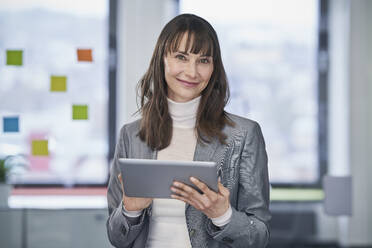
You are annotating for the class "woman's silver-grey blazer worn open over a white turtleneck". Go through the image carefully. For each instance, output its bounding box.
[106,114,271,248]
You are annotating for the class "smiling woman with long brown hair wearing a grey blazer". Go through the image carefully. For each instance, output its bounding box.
[107,14,270,248]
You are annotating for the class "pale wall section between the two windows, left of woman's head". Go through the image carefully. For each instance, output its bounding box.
[117,0,176,133]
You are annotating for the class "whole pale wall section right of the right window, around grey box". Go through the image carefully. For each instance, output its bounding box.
[329,0,372,246]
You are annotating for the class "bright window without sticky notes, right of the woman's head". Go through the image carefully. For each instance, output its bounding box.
[180,0,320,185]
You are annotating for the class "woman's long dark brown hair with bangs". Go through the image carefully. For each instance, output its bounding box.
[138,14,233,150]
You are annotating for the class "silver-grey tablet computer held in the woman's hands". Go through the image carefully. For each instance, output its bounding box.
[119,158,218,198]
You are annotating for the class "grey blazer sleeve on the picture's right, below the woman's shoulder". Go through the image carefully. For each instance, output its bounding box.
[207,123,271,248]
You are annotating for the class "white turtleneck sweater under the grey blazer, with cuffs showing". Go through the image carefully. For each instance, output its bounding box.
[124,96,232,248]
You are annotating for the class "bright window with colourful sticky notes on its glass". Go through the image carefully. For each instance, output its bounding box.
[0,0,109,185]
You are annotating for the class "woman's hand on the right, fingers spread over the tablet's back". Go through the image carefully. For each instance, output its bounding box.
[171,177,230,218]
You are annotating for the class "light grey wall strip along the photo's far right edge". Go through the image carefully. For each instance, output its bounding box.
[349,0,372,245]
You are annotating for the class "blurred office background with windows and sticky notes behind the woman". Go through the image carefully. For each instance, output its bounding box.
[0,0,372,248]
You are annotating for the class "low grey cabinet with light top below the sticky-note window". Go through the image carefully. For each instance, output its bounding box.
[0,188,112,248]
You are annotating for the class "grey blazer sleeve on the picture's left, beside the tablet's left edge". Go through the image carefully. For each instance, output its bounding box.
[106,126,148,248]
